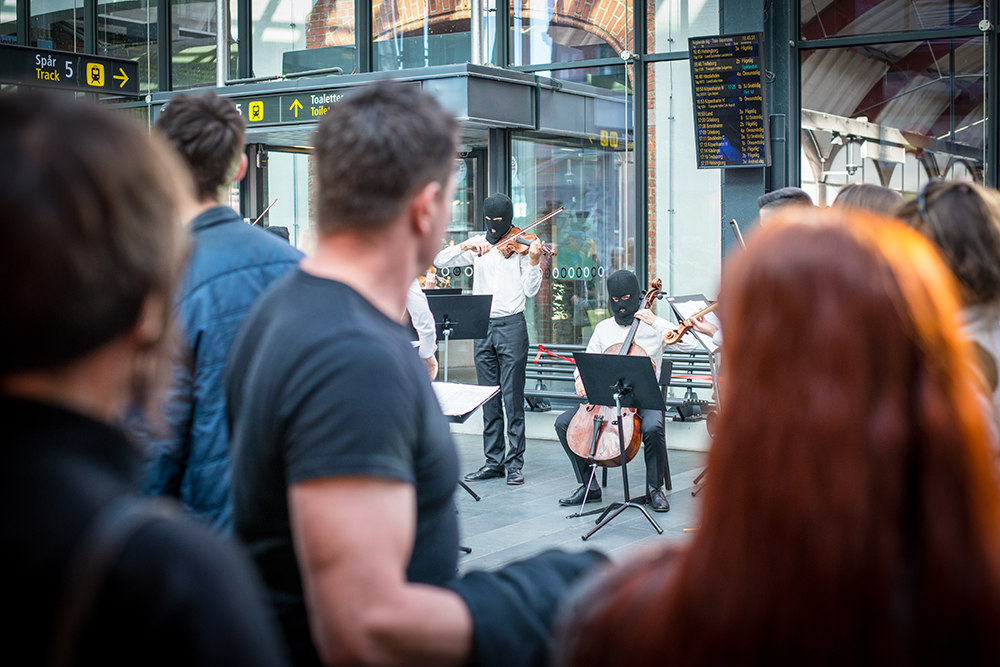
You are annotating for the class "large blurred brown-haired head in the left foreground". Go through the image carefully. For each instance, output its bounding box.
[0,93,190,375]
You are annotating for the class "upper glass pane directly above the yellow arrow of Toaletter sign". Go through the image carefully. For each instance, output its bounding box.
[252,0,354,76]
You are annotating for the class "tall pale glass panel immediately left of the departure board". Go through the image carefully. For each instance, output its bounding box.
[646,60,720,300]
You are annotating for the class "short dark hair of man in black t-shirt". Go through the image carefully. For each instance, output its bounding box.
[315,81,458,235]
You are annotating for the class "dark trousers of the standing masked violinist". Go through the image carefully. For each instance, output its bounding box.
[473,313,528,470]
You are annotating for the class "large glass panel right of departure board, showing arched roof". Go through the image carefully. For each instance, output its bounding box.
[801,37,988,200]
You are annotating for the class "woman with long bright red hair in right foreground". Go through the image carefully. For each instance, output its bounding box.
[557,209,1000,667]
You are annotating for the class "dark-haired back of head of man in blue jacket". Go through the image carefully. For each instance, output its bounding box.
[156,91,246,201]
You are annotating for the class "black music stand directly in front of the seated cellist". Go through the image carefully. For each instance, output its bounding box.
[573,352,666,540]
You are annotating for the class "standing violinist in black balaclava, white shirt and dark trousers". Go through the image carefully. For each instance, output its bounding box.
[434,193,542,485]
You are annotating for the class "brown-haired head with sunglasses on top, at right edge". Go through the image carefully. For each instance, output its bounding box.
[897,181,1000,304]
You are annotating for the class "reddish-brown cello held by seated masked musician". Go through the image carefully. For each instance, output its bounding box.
[566,278,663,468]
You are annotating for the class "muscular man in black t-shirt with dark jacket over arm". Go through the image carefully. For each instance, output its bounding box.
[226,83,600,666]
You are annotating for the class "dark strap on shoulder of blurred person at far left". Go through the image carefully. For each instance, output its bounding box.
[48,495,178,667]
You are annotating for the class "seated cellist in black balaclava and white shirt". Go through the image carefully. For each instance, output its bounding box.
[556,271,697,512]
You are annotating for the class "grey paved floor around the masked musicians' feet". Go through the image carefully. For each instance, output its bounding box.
[454,433,705,573]
